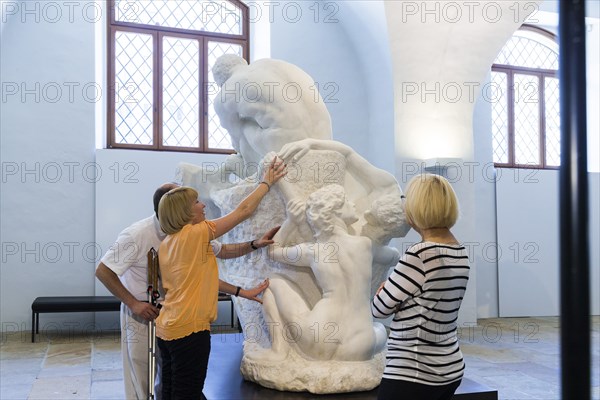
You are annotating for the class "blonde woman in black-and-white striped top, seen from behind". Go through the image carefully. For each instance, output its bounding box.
[371,174,469,400]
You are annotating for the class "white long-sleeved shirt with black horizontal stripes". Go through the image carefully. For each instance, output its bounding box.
[371,242,469,385]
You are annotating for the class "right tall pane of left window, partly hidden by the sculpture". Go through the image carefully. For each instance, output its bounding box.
[207,41,243,149]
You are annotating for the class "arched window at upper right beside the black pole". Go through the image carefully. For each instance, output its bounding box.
[492,26,560,168]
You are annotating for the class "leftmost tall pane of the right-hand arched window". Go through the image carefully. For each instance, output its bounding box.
[489,72,508,164]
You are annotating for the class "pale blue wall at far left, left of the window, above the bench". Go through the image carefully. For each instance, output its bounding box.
[0,2,97,332]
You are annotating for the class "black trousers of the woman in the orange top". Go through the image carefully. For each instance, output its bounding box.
[157,331,210,400]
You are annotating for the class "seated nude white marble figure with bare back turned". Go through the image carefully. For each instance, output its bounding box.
[258,184,387,361]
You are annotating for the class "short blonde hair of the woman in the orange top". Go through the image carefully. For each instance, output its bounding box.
[158,186,198,235]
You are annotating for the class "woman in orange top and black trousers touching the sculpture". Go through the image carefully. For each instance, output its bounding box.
[156,158,285,400]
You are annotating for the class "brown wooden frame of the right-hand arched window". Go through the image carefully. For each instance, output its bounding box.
[492,25,560,169]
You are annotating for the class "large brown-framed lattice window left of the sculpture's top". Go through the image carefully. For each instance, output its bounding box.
[107,0,249,153]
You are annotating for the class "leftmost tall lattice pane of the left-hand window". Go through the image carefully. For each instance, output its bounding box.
[115,31,153,145]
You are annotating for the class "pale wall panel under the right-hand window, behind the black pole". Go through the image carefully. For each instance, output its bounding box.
[496,169,600,317]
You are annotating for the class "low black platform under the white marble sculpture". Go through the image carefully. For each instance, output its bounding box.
[204,334,498,400]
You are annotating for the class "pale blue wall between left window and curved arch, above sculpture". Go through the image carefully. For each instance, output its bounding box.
[264,1,369,157]
